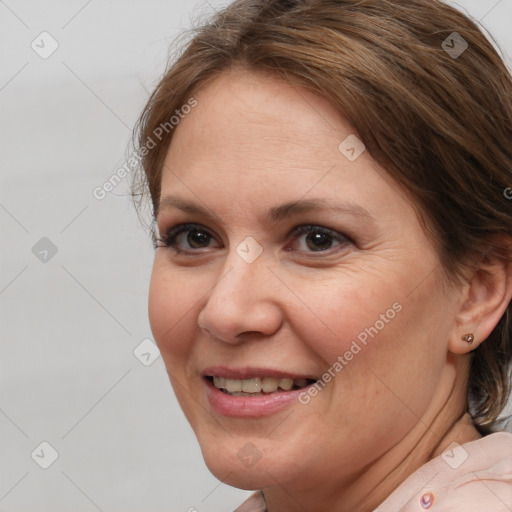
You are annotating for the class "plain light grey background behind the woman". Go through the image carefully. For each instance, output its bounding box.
[0,0,512,512]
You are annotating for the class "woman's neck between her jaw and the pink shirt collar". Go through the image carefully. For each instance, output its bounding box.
[263,360,482,512]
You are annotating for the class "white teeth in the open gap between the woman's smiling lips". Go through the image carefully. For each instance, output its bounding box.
[205,375,316,397]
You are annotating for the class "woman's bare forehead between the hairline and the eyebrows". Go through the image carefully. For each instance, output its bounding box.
[162,71,416,225]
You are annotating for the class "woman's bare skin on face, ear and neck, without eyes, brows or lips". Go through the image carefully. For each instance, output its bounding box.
[149,70,512,512]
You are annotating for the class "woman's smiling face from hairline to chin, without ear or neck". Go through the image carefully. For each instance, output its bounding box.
[149,71,459,489]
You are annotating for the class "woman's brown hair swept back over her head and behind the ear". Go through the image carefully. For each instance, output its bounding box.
[132,0,512,435]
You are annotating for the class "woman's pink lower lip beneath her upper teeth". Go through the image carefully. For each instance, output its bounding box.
[204,379,307,418]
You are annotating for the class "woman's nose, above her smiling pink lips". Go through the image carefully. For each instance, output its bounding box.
[197,254,282,344]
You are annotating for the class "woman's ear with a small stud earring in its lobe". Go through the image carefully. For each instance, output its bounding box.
[448,246,512,354]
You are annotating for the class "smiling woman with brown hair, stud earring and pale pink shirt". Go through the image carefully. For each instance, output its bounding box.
[135,0,512,512]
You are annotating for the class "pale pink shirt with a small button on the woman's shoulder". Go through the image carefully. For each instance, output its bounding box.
[235,432,512,512]
